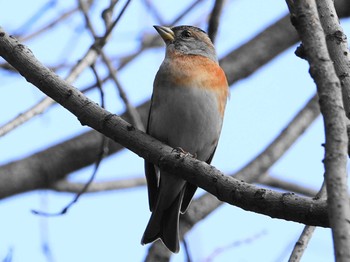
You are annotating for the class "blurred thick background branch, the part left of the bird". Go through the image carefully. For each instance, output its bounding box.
[0,102,149,199]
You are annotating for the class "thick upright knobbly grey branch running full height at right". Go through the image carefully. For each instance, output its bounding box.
[291,0,350,261]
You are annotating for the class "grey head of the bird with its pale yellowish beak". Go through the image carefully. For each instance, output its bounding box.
[154,25,218,62]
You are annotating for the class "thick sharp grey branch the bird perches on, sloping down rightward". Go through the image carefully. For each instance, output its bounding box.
[0,26,328,226]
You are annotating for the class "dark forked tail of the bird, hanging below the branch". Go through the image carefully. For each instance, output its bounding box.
[141,185,185,253]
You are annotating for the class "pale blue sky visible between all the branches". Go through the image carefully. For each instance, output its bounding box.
[0,0,350,262]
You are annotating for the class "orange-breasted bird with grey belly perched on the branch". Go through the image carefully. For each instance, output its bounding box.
[141,25,229,253]
